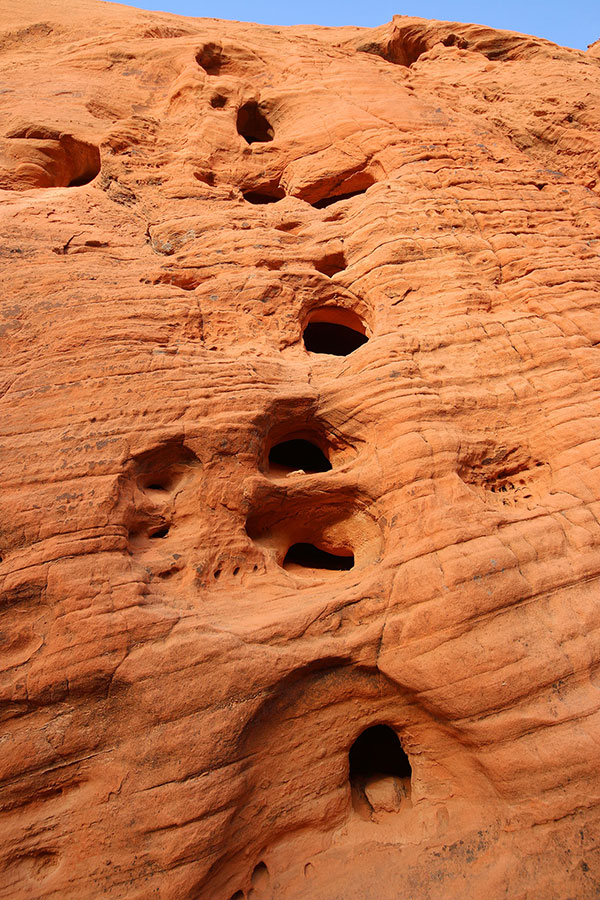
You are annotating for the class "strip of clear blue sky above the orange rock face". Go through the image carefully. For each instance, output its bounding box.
[110,0,600,50]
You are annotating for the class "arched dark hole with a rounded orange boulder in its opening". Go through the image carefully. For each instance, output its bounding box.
[349,725,412,818]
